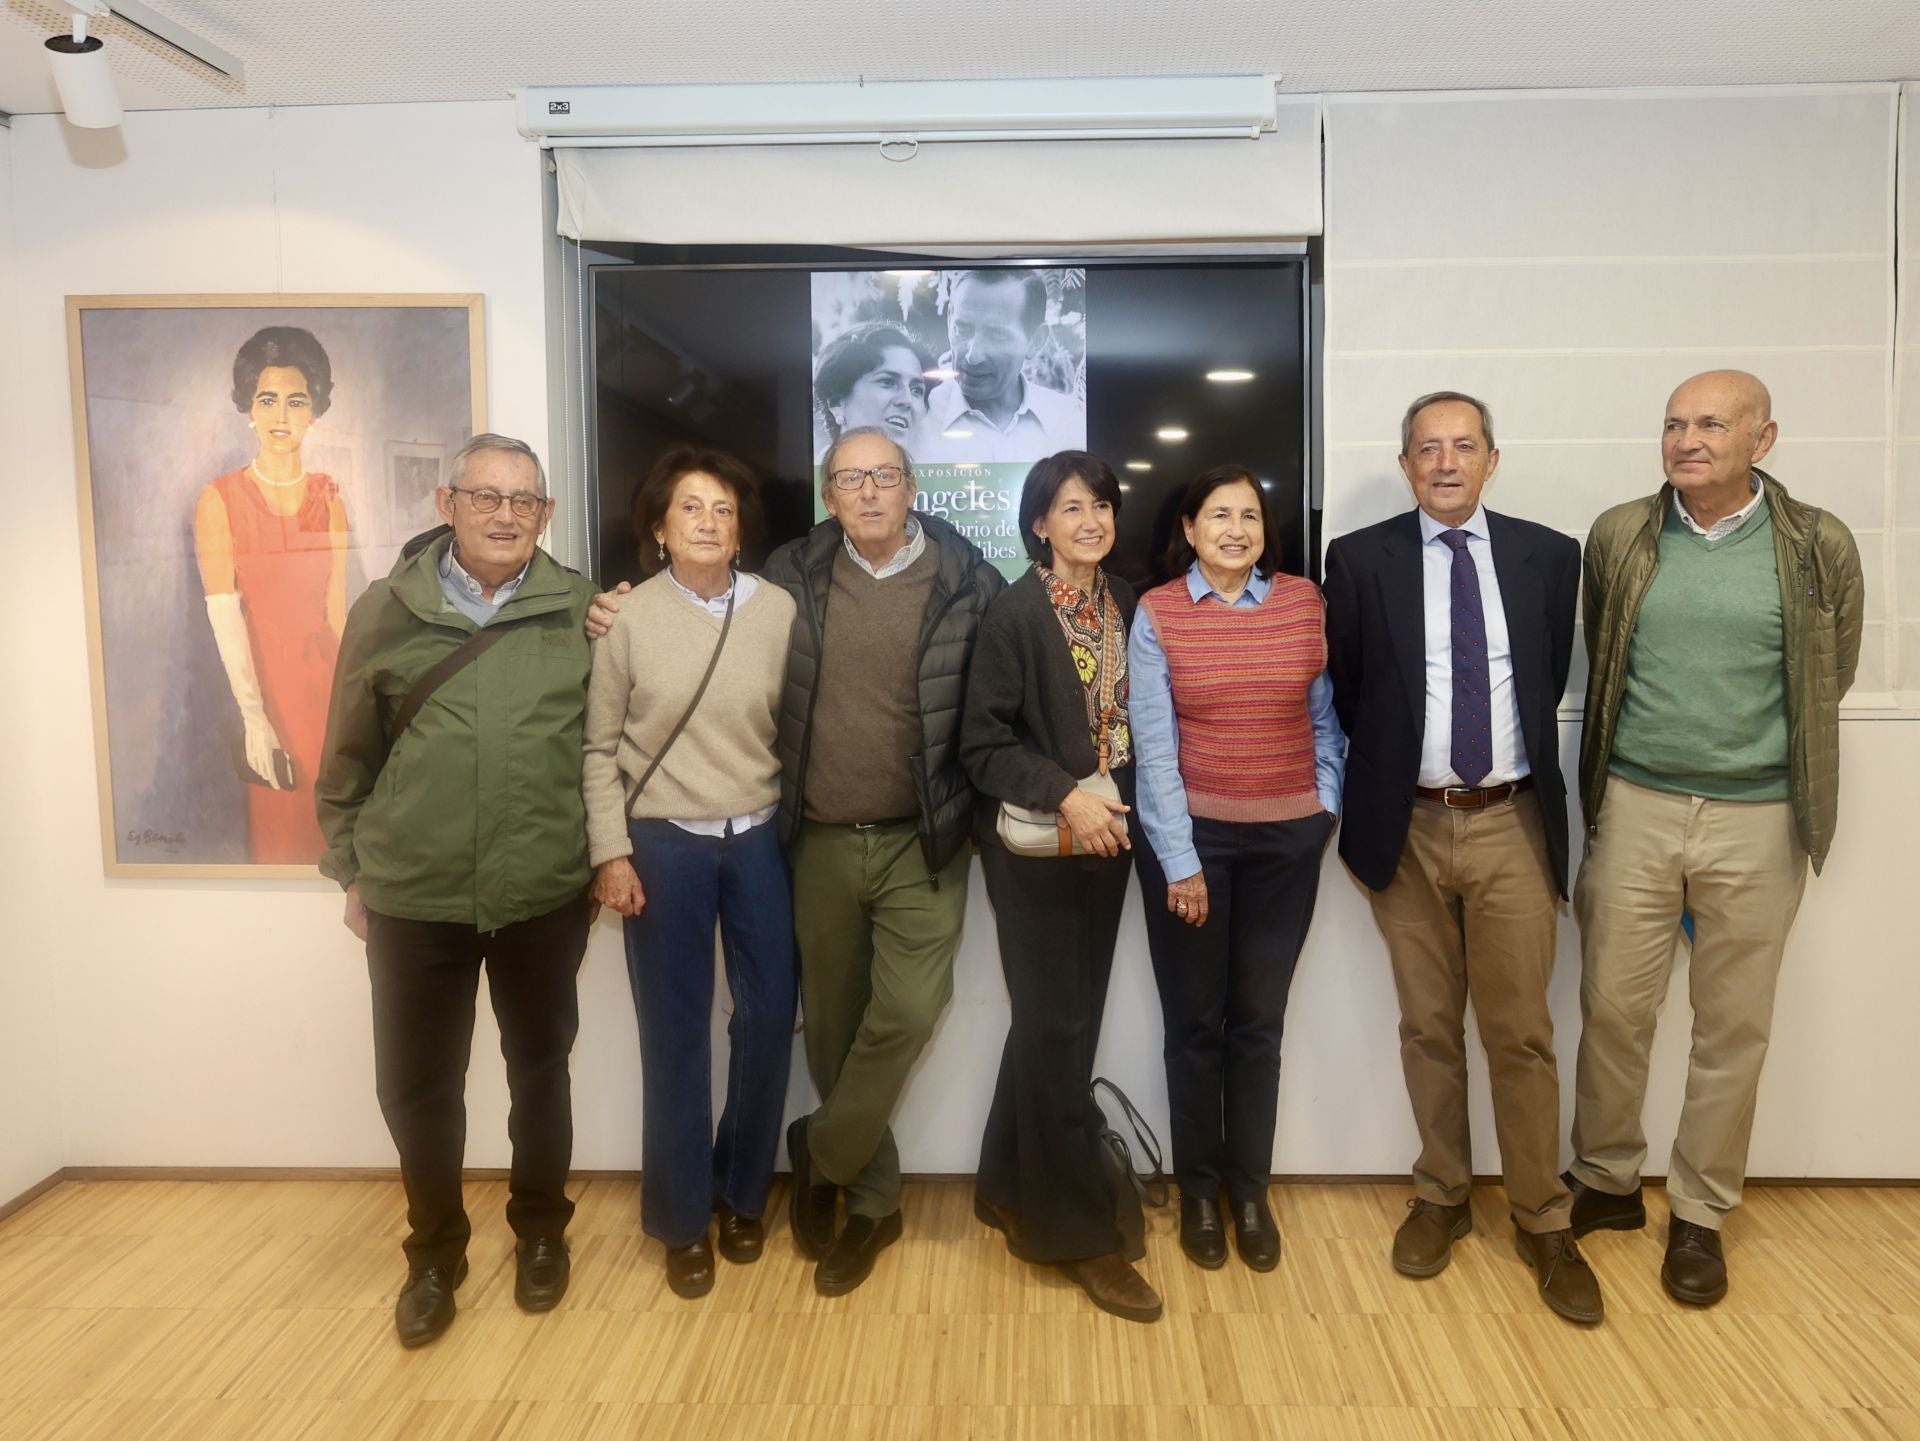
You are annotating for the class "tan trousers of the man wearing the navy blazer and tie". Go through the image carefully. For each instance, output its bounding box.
[1371,792,1571,1232]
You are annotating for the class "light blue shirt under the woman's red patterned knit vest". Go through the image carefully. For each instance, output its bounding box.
[1127,560,1346,881]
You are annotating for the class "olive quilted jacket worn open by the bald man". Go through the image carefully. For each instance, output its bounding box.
[1580,468,1866,875]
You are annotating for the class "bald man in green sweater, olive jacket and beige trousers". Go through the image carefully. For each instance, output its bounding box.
[1567,370,1862,1307]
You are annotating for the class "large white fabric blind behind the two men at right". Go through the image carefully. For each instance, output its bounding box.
[1323,84,1920,708]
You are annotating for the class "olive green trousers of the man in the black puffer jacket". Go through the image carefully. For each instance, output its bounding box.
[787,821,973,1220]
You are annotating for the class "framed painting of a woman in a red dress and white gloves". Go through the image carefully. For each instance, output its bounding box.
[67,295,486,879]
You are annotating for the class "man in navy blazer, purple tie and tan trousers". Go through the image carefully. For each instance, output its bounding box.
[1327,391,1603,1324]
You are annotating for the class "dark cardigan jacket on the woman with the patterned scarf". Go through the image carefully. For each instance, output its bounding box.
[960,570,1133,844]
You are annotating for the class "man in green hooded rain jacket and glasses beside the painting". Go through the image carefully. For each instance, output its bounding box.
[315,436,593,1347]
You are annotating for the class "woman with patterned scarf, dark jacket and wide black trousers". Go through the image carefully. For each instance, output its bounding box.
[960,451,1162,1320]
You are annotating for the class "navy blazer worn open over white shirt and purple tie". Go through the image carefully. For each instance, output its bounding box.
[1325,510,1580,896]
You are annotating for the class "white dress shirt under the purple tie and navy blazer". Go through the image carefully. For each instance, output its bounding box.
[1419,507,1530,787]
